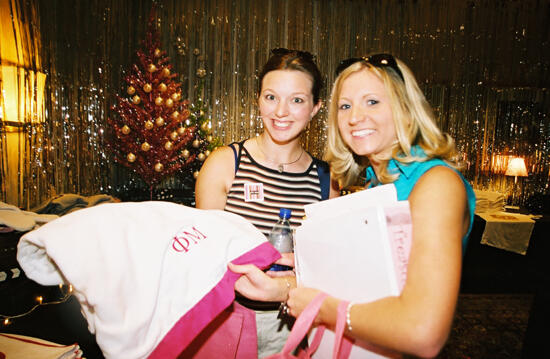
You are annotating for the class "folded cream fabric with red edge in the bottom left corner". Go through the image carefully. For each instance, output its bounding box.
[0,333,82,359]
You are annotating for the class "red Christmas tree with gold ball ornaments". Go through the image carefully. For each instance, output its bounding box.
[107,9,216,199]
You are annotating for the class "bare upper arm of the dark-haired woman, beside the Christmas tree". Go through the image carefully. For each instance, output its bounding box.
[195,146,235,210]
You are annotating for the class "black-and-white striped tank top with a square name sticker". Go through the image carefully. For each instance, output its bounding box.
[224,141,321,236]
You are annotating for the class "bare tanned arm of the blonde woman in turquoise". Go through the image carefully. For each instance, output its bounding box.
[288,166,469,357]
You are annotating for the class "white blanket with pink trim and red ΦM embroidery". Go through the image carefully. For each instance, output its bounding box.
[17,202,279,359]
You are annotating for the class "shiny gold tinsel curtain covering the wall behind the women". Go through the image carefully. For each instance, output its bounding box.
[0,0,550,208]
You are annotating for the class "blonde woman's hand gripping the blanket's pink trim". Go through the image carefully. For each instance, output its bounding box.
[227,263,286,302]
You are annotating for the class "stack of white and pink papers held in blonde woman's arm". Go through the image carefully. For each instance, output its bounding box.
[294,184,412,358]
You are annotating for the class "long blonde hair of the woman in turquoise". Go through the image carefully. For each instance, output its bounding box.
[324,59,459,188]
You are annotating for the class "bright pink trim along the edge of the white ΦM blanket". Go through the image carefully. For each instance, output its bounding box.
[148,242,281,359]
